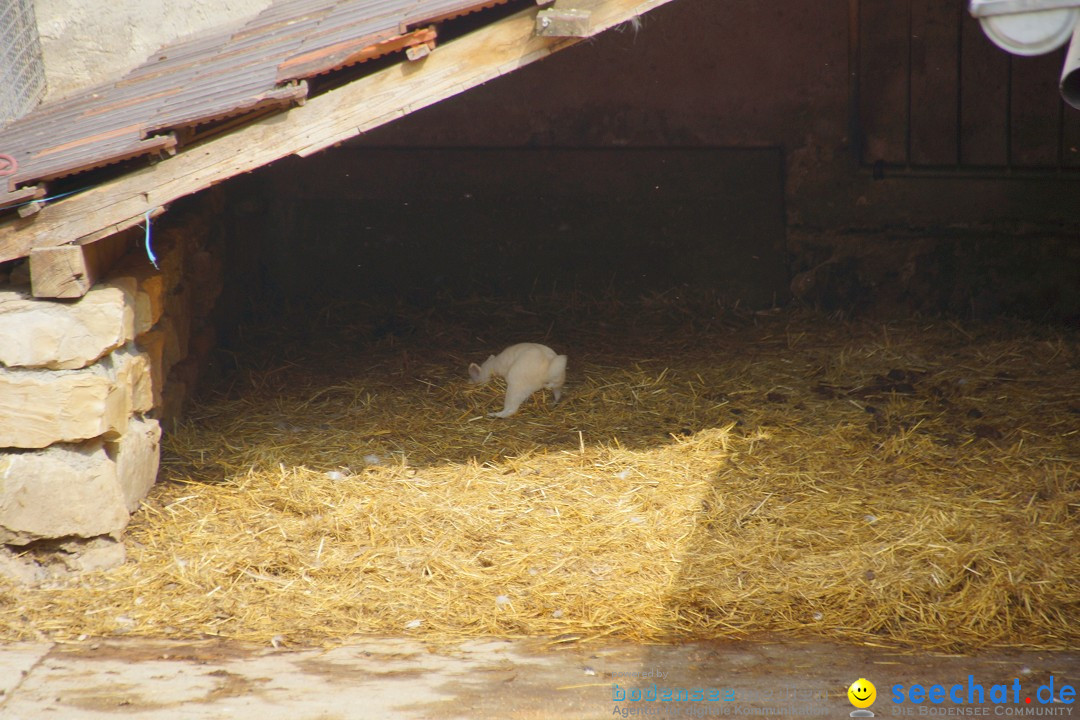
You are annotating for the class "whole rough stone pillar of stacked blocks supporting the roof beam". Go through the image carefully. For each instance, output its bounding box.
[0,203,222,575]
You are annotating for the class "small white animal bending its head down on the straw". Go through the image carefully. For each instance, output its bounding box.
[469,342,566,418]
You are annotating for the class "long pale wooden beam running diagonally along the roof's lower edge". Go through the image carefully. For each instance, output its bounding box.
[0,0,671,261]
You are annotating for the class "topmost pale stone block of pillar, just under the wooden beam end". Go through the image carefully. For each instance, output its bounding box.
[0,277,136,370]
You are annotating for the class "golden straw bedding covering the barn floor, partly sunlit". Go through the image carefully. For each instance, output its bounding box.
[0,297,1080,651]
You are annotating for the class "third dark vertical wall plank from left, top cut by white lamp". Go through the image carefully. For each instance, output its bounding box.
[960,8,1009,166]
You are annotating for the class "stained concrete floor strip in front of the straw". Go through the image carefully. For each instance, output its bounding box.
[0,638,1080,720]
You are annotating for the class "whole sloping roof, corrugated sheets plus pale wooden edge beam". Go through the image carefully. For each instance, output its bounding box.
[0,0,671,268]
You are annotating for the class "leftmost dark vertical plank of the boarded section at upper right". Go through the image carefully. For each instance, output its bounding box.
[859,0,909,163]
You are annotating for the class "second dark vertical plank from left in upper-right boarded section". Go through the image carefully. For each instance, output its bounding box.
[910,0,961,165]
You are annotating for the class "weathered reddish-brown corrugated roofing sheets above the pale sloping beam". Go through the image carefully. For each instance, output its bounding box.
[0,0,510,208]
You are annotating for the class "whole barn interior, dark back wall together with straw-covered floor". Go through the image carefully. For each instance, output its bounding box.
[2,0,1080,652]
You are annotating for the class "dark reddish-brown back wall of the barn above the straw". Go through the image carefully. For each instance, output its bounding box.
[210,0,1080,323]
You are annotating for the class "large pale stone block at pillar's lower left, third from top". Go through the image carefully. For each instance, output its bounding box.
[0,440,127,545]
